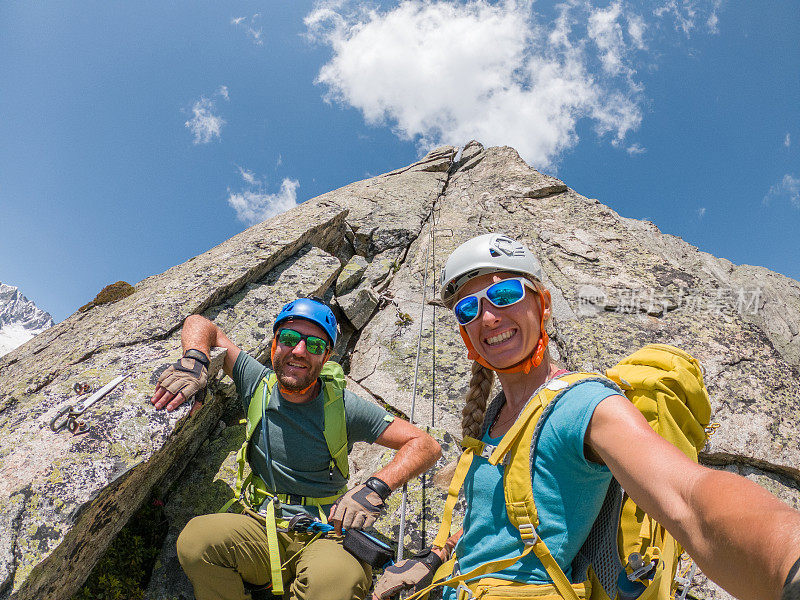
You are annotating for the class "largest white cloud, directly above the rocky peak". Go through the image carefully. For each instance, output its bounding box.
[305,0,645,167]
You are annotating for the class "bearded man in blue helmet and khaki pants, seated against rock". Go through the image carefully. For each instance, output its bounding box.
[151,298,441,600]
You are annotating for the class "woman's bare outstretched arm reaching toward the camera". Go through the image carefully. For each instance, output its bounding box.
[585,396,800,600]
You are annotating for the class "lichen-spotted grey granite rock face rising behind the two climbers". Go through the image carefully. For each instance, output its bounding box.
[0,142,800,600]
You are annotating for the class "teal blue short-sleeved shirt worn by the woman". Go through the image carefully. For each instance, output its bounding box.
[445,381,619,598]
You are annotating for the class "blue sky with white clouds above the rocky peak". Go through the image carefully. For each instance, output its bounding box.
[0,0,800,321]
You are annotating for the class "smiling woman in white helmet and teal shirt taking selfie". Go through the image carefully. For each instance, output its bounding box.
[373,234,800,600]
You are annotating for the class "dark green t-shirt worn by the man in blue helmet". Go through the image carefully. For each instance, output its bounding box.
[233,352,393,498]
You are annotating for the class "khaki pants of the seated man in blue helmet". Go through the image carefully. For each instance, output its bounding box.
[177,513,372,600]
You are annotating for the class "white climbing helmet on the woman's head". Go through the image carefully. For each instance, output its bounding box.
[441,233,542,308]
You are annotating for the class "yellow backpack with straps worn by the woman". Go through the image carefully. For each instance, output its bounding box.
[409,344,711,600]
